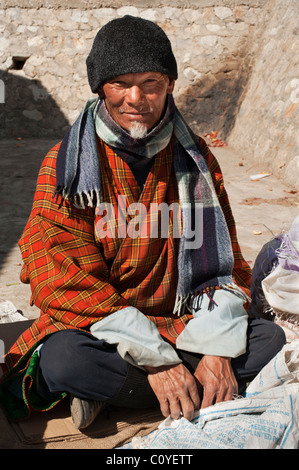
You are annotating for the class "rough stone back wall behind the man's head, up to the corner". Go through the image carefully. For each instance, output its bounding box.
[0,0,265,138]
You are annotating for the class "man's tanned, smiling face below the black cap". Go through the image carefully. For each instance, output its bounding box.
[103,72,175,131]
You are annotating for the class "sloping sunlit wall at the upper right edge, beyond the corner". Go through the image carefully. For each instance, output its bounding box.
[229,0,299,189]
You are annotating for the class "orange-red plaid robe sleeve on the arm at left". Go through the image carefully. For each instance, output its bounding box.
[19,146,128,328]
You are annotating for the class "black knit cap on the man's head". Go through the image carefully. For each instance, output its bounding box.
[86,15,178,93]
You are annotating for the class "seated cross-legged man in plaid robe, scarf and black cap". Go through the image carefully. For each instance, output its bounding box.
[0,16,285,429]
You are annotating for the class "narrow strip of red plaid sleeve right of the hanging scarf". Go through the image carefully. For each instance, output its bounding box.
[199,138,251,296]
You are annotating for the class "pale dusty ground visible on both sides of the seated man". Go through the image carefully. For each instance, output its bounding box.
[0,139,299,448]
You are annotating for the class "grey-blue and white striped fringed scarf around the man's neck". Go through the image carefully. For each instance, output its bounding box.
[55,96,248,315]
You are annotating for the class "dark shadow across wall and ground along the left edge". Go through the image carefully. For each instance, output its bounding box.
[0,70,69,268]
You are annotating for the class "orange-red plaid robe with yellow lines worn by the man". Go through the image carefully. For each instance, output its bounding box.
[1,139,251,375]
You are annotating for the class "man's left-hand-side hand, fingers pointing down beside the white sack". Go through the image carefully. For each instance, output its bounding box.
[146,364,200,421]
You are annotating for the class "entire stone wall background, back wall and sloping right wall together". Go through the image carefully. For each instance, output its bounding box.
[0,0,299,188]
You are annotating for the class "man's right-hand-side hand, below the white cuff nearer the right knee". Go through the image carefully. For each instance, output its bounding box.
[194,356,238,408]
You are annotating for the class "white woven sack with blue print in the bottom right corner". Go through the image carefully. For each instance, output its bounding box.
[130,340,299,449]
